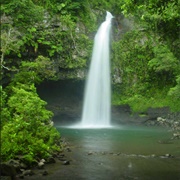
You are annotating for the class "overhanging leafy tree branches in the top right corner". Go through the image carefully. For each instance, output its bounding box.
[121,0,180,53]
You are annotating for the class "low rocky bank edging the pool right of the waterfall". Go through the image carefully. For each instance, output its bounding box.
[112,105,180,139]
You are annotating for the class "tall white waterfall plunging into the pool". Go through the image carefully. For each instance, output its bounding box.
[82,12,113,128]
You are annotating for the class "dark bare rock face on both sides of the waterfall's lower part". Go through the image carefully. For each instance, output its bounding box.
[37,80,179,126]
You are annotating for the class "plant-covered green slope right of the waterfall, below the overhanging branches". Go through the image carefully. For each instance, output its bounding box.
[112,27,180,112]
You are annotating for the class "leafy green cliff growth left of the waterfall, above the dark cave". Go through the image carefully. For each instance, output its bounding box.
[1,0,95,81]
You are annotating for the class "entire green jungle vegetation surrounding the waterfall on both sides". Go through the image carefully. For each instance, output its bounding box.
[0,0,180,164]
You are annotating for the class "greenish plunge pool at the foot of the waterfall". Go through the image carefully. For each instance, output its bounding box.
[58,126,180,180]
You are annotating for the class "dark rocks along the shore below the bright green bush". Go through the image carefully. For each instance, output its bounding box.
[0,141,71,180]
